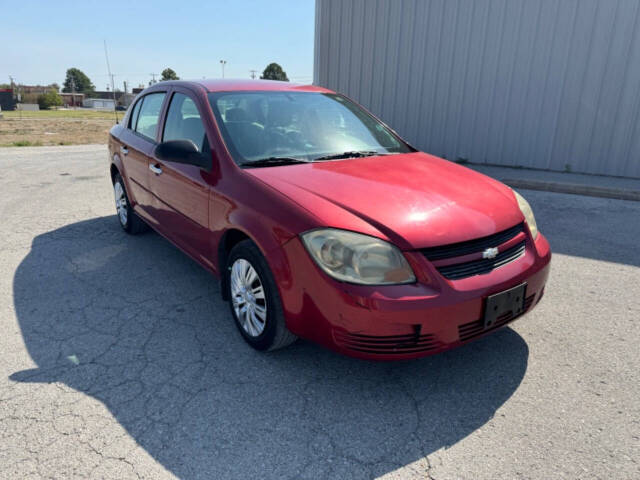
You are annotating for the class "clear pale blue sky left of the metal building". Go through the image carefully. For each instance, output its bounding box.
[0,0,315,90]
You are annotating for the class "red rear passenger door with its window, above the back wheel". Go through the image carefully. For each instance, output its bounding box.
[120,92,167,220]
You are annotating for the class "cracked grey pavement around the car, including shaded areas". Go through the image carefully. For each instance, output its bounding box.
[0,146,640,480]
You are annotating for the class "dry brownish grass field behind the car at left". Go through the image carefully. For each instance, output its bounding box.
[0,110,125,147]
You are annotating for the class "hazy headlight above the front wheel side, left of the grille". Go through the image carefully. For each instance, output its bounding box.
[301,228,416,285]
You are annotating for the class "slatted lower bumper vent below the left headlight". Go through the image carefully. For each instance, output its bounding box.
[334,330,441,355]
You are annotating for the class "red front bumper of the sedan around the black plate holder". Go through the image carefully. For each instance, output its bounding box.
[274,234,551,360]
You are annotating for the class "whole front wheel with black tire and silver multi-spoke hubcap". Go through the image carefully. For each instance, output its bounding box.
[226,240,297,350]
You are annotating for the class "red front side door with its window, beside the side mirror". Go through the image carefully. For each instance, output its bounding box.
[149,87,212,266]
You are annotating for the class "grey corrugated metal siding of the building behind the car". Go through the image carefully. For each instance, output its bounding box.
[314,0,640,177]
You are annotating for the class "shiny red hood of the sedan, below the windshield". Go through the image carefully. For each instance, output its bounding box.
[245,152,523,249]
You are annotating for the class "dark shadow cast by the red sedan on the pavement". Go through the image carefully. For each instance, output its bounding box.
[10,217,528,479]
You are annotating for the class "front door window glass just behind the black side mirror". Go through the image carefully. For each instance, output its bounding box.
[162,93,205,152]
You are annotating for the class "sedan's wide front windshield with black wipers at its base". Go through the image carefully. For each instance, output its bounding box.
[209,91,413,166]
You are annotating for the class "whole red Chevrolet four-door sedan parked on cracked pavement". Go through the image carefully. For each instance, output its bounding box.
[109,80,551,360]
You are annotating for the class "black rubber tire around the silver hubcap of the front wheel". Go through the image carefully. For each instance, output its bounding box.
[225,240,298,351]
